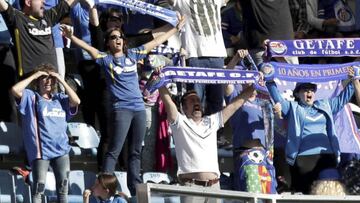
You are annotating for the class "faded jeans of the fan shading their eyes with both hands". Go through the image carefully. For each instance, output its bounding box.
[32,154,70,203]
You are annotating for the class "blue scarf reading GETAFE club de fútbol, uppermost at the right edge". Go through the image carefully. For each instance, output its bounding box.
[266,38,360,57]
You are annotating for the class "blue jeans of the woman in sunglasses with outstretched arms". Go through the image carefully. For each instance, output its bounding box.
[103,109,146,196]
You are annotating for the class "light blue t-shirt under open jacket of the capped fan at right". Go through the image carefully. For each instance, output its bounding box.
[299,106,333,155]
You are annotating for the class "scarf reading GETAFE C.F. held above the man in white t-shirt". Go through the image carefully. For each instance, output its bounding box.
[146,66,260,92]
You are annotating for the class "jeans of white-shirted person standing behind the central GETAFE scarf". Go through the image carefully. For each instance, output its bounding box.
[187,57,224,115]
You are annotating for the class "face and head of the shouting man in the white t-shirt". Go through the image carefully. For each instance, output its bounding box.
[183,94,202,119]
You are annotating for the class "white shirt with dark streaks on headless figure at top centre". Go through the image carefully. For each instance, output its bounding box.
[173,0,226,58]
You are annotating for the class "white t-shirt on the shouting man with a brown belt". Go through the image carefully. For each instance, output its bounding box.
[170,112,223,177]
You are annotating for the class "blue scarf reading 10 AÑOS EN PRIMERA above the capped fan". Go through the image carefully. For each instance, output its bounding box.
[260,62,360,82]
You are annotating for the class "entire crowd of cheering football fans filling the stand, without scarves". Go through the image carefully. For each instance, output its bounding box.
[0,0,360,202]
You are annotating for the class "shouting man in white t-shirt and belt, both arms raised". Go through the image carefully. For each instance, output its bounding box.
[159,80,254,203]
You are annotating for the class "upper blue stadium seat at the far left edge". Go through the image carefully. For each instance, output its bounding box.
[0,121,24,155]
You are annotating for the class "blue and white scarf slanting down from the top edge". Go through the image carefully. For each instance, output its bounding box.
[95,0,178,27]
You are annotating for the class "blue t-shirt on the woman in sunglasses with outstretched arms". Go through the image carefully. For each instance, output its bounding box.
[96,46,147,111]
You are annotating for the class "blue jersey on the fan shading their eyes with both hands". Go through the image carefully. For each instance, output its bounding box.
[18,89,77,164]
